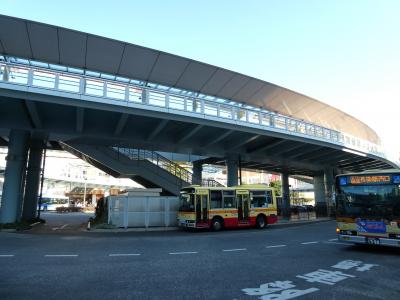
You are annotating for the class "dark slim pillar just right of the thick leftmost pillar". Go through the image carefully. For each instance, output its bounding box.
[22,139,44,220]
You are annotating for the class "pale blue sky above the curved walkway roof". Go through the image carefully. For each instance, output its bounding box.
[0,0,400,160]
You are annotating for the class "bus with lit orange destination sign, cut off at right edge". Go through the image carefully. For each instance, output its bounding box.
[335,169,400,247]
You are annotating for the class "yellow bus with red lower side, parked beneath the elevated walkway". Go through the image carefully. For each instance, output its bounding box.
[178,185,278,231]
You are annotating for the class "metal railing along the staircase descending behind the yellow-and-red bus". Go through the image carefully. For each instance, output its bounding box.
[113,147,223,186]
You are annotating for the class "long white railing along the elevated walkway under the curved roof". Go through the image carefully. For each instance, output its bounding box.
[0,57,386,158]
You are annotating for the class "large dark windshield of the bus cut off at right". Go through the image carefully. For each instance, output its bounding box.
[336,184,400,218]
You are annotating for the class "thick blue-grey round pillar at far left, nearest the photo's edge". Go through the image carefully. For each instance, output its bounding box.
[0,130,29,223]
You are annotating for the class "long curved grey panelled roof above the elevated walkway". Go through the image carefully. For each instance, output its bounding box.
[0,15,380,144]
